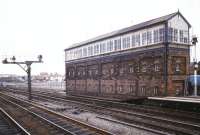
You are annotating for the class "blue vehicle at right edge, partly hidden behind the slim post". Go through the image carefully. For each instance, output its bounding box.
[185,75,200,96]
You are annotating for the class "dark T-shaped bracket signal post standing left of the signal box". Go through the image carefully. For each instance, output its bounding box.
[2,55,43,100]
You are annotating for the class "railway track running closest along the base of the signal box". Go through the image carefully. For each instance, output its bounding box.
[3,86,200,123]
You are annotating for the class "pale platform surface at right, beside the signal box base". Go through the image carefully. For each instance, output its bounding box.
[148,96,200,104]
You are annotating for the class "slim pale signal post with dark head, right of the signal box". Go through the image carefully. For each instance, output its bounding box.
[192,36,198,96]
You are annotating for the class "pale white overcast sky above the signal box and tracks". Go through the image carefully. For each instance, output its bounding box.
[0,0,200,75]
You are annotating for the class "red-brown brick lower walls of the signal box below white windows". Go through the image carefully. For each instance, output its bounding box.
[66,48,189,97]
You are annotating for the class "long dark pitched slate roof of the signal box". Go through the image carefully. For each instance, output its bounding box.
[65,11,191,51]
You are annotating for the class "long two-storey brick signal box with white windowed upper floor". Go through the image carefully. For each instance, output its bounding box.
[65,12,191,99]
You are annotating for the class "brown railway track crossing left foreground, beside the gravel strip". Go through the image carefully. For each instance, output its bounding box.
[0,91,112,135]
